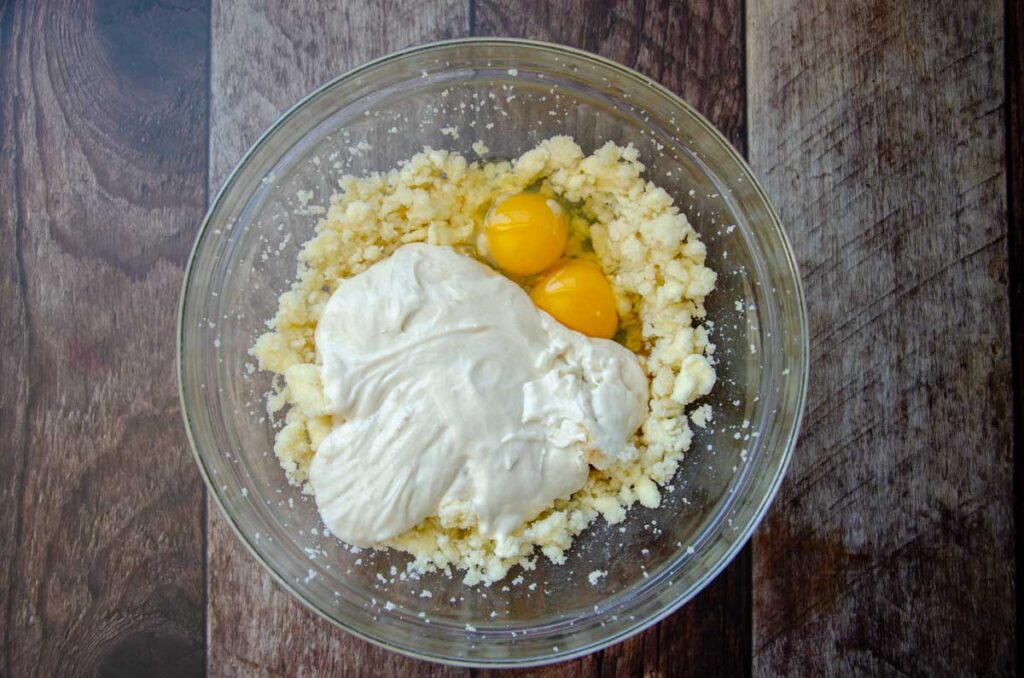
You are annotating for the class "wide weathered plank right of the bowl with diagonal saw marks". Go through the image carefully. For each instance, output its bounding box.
[746,0,1020,675]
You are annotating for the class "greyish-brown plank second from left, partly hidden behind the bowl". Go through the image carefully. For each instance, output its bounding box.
[208,0,469,676]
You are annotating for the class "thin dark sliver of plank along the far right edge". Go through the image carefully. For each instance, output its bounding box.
[1006,0,1024,673]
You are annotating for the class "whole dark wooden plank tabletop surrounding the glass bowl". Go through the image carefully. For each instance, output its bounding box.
[0,0,1024,676]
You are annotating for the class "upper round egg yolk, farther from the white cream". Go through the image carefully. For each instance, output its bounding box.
[484,193,569,276]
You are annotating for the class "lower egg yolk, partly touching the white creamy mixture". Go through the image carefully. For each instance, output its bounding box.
[529,259,618,339]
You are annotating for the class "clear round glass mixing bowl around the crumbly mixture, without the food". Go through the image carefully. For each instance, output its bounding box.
[177,39,808,667]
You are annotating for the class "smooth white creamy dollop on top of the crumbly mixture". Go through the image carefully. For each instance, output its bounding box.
[309,244,647,546]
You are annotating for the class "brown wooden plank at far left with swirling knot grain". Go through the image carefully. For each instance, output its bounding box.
[0,0,209,676]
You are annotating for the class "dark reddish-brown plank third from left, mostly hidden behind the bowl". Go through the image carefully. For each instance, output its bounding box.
[474,0,751,676]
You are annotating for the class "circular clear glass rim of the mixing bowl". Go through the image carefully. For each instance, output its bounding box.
[175,37,810,668]
